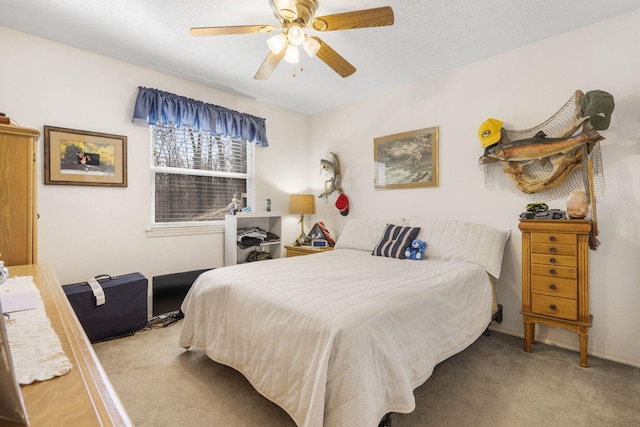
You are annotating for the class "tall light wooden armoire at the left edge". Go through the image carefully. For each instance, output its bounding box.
[0,124,40,266]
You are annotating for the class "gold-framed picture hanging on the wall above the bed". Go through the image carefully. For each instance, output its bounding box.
[373,126,439,190]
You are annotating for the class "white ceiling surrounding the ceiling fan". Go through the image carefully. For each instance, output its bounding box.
[0,0,640,114]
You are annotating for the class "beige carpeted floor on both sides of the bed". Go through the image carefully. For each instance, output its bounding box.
[94,322,640,427]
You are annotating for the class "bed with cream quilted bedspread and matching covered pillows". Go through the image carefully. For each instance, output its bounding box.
[179,219,509,427]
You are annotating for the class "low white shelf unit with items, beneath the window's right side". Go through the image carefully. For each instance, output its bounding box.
[224,212,282,267]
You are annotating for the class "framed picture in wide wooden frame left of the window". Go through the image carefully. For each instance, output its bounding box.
[44,126,127,187]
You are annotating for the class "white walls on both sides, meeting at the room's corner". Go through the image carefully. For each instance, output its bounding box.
[0,11,640,366]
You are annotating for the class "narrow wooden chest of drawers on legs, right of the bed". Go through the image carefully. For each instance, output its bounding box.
[518,220,592,367]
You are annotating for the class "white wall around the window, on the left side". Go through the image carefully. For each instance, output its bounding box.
[0,27,308,283]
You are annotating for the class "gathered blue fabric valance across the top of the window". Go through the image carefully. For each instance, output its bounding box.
[133,86,269,147]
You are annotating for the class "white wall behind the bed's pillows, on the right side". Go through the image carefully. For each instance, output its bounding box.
[310,11,640,366]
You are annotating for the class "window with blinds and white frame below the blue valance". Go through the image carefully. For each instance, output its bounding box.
[151,124,255,224]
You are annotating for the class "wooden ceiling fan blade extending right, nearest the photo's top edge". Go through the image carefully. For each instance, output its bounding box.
[311,6,394,31]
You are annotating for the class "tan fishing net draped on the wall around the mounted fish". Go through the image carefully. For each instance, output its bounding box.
[480,90,605,202]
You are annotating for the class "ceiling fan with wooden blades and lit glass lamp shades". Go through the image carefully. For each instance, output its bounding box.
[190,0,394,80]
